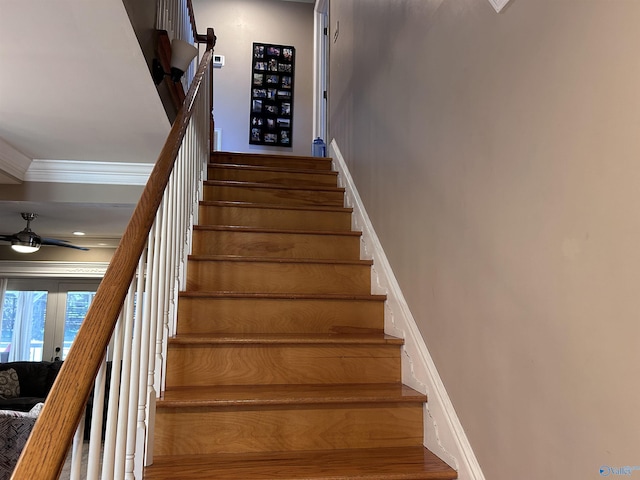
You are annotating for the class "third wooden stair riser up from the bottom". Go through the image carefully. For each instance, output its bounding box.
[177,297,384,334]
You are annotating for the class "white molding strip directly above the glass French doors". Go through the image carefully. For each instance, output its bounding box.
[0,261,109,278]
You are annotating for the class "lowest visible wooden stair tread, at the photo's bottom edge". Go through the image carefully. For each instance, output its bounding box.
[144,447,457,480]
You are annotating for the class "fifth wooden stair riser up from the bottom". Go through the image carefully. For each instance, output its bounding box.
[193,229,360,260]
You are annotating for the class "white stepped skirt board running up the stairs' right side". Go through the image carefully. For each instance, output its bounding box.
[329,139,485,480]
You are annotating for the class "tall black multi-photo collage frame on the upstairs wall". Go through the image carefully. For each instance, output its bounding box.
[249,43,296,147]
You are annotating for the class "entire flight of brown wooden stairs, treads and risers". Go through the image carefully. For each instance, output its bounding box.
[144,153,457,480]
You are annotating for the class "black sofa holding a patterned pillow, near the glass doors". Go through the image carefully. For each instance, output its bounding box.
[0,362,62,412]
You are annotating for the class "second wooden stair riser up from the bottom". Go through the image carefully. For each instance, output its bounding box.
[167,344,400,388]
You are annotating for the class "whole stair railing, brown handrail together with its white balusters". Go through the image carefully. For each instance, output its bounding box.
[11,25,215,480]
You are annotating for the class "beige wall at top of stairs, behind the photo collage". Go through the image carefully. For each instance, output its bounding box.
[193,0,313,155]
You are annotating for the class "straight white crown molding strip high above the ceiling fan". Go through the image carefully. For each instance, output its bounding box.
[25,160,153,185]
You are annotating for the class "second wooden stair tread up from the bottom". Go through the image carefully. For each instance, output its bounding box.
[158,383,427,408]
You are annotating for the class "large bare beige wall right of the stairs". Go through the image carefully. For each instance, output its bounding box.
[330,0,640,480]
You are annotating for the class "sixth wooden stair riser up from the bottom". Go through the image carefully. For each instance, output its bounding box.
[199,205,351,232]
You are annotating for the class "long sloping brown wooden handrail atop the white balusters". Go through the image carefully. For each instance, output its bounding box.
[11,28,215,480]
